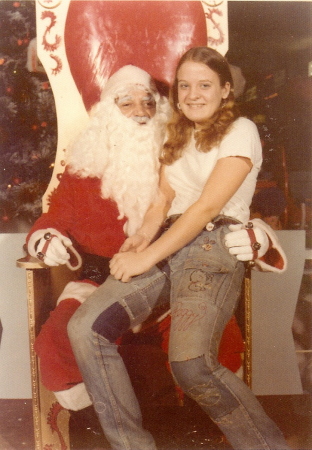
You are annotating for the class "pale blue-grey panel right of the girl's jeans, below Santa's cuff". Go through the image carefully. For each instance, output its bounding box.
[251,230,306,395]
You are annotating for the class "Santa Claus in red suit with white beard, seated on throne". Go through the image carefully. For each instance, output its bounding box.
[27,65,286,418]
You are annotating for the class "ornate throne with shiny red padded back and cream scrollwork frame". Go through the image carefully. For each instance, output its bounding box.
[17,0,251,450]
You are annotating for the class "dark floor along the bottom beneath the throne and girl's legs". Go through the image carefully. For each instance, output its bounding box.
[0,395,312,450]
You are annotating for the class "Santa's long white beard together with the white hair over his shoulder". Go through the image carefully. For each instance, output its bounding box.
[68,102,167,236]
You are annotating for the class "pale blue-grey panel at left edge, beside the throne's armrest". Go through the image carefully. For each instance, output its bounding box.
[0,233,31,399]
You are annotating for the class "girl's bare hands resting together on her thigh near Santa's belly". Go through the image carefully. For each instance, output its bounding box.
[109,252,153,283]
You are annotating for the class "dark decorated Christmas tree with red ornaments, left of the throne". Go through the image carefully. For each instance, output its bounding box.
[0,1,57,233]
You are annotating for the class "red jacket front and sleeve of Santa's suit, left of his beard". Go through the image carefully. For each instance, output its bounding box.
[26,170,127,257]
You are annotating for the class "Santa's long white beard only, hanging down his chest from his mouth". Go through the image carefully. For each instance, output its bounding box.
[101,108,162,235]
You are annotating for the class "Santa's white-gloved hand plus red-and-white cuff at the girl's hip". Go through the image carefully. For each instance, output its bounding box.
[225,219,287,273]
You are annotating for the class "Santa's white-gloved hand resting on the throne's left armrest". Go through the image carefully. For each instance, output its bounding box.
[28,228,72,266]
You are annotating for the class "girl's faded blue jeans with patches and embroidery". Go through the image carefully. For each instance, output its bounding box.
[68,226,289,450]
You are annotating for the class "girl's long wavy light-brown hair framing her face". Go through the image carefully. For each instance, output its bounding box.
[160,47,240,165]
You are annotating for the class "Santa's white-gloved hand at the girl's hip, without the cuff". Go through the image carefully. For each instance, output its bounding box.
[225,221,270,261]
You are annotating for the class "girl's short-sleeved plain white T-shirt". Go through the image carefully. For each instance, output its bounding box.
[165,117,262,223]
